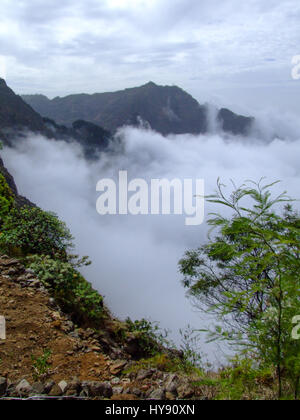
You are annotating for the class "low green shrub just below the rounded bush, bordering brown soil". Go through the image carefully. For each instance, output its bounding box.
[28,255,104,325]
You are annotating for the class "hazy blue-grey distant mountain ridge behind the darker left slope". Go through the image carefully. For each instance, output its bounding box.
[23,82,253,135]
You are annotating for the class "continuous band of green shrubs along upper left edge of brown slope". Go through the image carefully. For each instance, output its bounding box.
[0,169,104,325]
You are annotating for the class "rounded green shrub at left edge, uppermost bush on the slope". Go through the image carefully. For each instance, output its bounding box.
[0,207,73,257]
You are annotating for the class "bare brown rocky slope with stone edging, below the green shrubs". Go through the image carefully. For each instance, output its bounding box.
[0,255,202,400]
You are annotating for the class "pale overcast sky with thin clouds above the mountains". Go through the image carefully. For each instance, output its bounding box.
[0,0,300,113]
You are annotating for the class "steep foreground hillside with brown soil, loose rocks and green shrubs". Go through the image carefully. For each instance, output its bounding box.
[0,161,200,400]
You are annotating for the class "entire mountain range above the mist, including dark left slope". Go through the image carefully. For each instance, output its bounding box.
[0,79,254,158]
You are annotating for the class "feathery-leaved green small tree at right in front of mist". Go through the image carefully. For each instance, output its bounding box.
[180,181,300,397]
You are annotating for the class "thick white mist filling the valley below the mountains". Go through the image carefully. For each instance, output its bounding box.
[1,119,300,358]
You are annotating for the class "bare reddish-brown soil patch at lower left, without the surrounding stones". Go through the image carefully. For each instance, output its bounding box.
[0,275,111,382]
